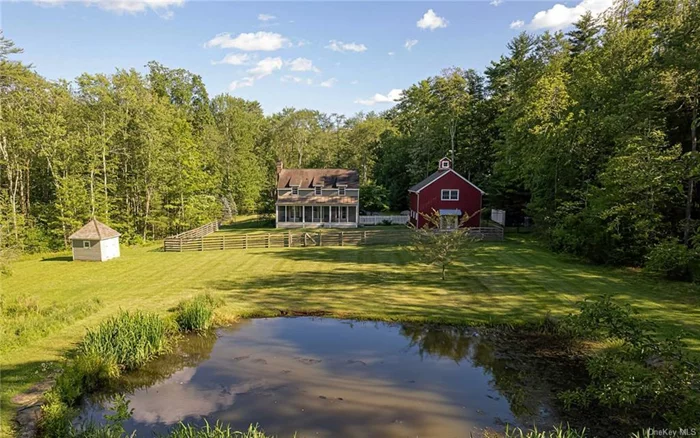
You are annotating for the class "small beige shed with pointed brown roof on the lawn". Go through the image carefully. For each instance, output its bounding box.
[69,219,121,262]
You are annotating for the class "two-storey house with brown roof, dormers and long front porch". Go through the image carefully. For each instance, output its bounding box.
[275,163,360,228]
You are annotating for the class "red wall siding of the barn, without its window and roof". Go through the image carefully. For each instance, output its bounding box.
[411,172,481,227]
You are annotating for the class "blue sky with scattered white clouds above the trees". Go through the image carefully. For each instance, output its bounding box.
[1,0,611,115]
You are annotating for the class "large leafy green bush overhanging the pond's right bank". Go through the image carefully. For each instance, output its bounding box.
[560,296,700,427]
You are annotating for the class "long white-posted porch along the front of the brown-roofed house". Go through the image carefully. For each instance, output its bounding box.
[275,205,360,228]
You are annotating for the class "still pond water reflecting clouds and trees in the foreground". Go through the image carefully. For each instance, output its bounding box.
[77,317,584,437]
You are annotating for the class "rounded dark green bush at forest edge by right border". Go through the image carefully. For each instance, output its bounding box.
[644,239,696,280]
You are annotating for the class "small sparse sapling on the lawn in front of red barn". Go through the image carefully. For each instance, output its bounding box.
[411,210,479,280]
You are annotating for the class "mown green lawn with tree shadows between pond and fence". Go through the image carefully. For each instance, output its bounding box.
[0,236,700,436]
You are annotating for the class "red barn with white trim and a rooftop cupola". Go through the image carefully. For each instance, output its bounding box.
[408,158,484,229]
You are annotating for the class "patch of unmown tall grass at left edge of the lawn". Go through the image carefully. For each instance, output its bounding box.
[0,295,101,353]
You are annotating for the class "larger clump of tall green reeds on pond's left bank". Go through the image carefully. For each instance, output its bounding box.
[79,311,174,370]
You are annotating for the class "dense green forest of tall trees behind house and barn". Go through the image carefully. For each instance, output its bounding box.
[0,0,700,265]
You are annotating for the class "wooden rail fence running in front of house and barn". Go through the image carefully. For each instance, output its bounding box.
[163,227,503,252]
